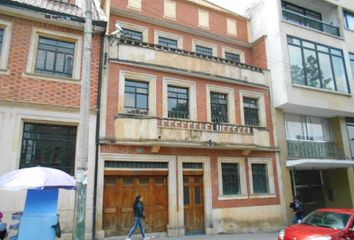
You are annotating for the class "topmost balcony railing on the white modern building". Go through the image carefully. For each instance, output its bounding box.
[283,9,340,36]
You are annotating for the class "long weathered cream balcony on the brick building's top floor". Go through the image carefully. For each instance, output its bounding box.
[109,39,269,86]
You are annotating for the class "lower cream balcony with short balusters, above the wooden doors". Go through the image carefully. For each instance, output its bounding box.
[115,113,270,149]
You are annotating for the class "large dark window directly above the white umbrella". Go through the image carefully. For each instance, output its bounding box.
[20,123,77,175]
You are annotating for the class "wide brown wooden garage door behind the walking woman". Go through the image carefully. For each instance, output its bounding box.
[103,176,168,236]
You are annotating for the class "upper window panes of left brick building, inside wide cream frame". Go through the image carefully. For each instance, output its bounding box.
[35,37,75,77]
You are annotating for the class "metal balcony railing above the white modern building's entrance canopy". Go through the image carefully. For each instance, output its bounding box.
[287,140,344,159]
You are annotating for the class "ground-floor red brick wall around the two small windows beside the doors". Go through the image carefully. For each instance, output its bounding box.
[101,145,280,208]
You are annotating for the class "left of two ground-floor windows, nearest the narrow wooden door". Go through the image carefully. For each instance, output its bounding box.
[221,163,241,195]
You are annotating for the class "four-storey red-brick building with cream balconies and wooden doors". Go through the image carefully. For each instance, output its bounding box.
[95,0,285,238]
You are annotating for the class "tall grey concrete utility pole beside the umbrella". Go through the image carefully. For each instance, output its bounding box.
[73,0,94,240]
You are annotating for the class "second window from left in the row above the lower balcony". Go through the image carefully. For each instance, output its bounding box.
[168,86,189,119]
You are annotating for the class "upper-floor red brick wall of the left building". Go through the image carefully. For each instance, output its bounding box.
[0,14,101,108]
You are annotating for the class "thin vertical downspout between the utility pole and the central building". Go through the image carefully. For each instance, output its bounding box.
[92,29,105,240]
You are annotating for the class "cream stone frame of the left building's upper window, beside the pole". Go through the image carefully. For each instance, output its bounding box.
[26,28,82,81]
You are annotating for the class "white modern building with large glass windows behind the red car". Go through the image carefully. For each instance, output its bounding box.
[239,0,354,223]
